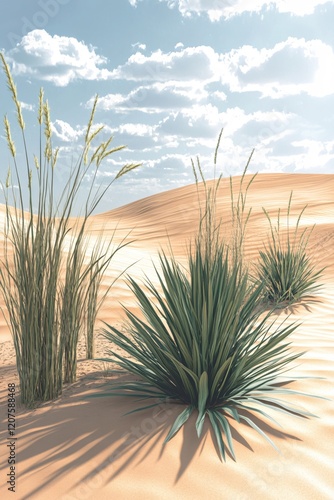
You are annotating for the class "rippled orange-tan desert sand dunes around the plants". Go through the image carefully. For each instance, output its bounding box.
[0,174,334,500]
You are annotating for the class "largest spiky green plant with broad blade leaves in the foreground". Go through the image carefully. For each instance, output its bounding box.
[96,136,316,459]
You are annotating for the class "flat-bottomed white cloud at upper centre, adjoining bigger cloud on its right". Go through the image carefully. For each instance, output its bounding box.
[112,46,219,83]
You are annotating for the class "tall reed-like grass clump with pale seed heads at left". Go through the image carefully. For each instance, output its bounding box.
[0,54,138,406]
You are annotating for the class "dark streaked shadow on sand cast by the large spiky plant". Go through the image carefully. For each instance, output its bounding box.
[2,373,306,499]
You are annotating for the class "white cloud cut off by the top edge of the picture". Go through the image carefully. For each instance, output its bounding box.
[142,0,334,22]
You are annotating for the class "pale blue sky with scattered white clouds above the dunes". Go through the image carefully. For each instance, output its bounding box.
[0,0,334,211]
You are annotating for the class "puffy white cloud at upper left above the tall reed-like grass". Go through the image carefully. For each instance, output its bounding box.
[5,30,111,87]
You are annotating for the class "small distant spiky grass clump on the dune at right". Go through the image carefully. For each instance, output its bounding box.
[254,193,324,307]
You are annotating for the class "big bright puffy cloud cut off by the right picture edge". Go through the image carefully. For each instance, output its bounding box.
[221,37,334,98]
